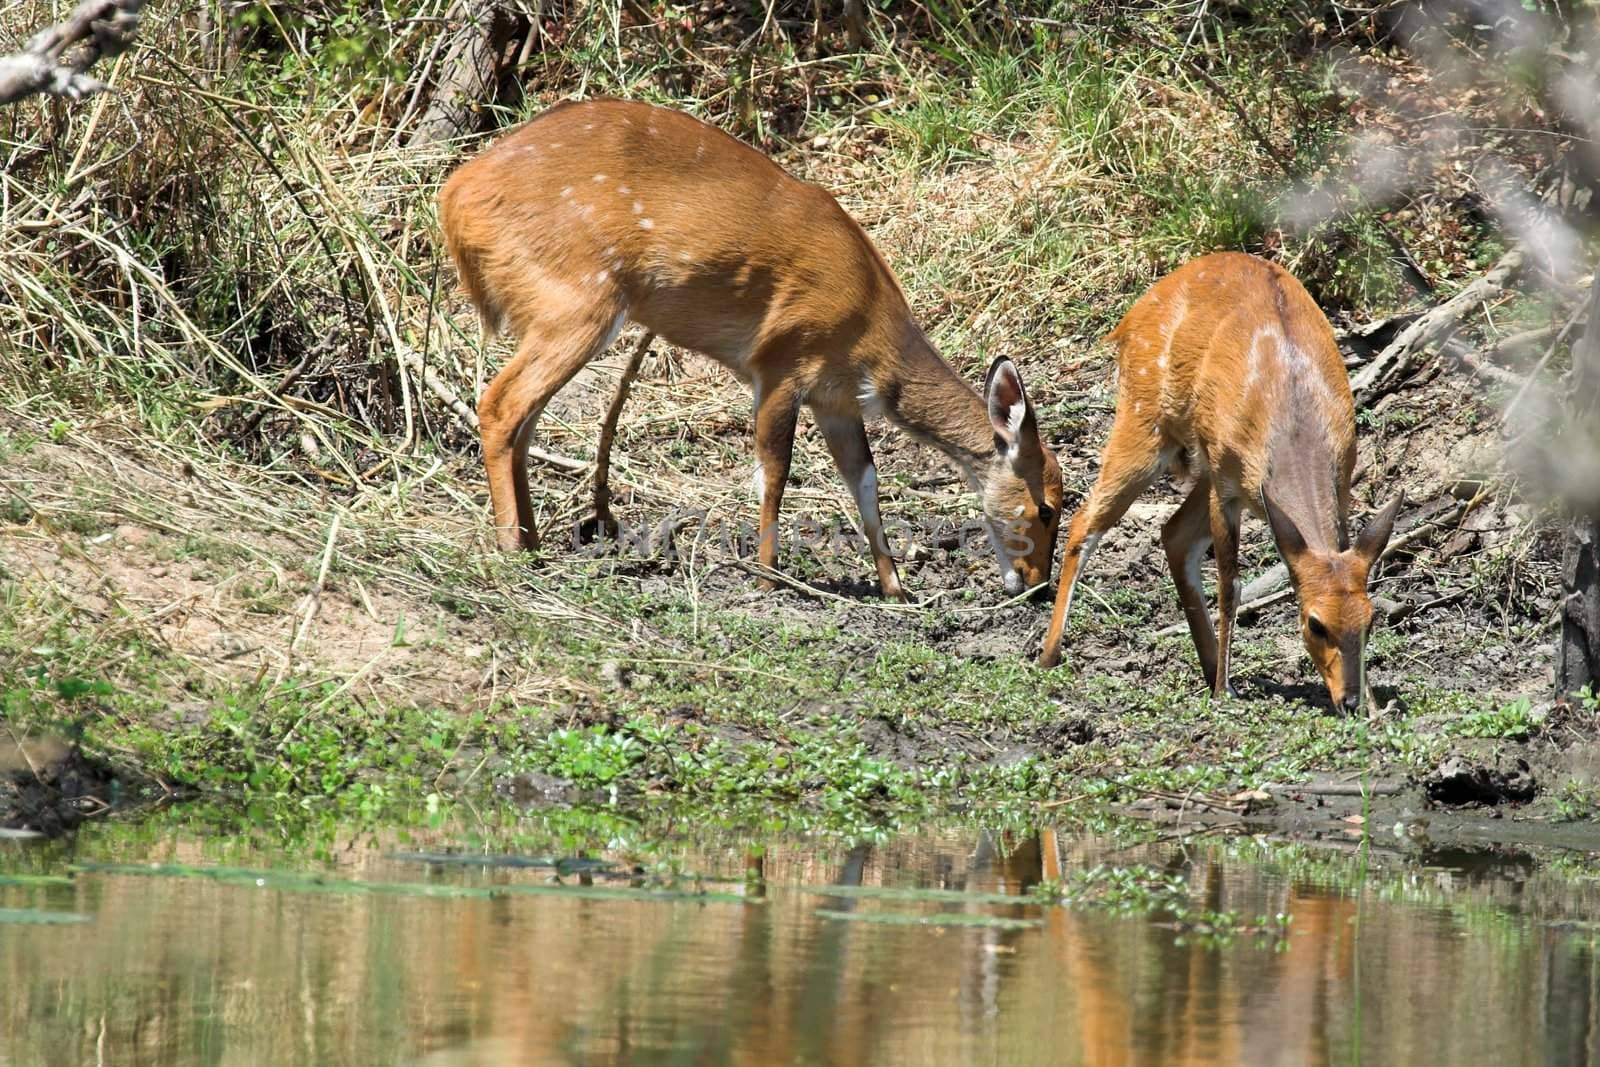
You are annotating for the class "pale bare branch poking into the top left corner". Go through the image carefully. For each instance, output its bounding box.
[0,0,141,104]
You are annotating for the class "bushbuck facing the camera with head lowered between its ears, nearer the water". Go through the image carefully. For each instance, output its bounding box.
[1038,253,1402,712]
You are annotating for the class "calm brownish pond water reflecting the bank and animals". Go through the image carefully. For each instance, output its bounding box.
[0,816,1600,1067]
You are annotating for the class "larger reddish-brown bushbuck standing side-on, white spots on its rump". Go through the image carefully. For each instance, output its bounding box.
[438,99,1061,600]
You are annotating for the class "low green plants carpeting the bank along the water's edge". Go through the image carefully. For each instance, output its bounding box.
[0,543,1510,822]
